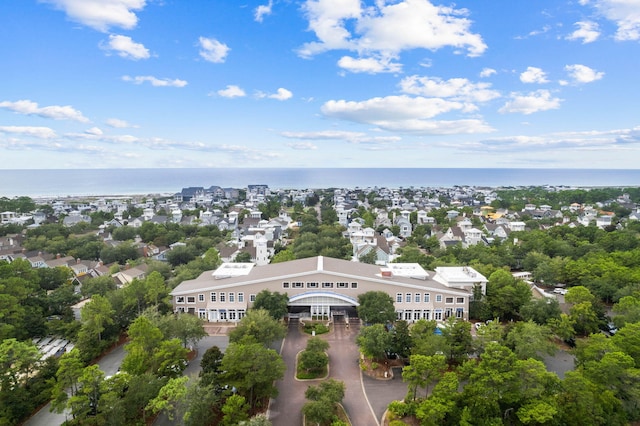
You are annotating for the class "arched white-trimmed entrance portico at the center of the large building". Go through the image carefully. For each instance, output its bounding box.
[289,291,358,319]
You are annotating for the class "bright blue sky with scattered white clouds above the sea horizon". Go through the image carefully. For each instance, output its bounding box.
[0,0,640,169]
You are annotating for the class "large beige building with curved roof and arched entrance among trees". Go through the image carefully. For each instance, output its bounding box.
[171,256,487,322]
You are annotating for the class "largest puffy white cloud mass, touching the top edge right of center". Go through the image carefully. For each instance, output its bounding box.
[298,0,487,72]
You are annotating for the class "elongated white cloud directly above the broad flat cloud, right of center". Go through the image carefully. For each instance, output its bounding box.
[400,75,500,102]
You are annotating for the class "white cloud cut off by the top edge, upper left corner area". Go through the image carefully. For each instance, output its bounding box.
[41,0,146,32]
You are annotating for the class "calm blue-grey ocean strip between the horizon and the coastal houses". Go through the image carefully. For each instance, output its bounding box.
[0,168,640,198]
